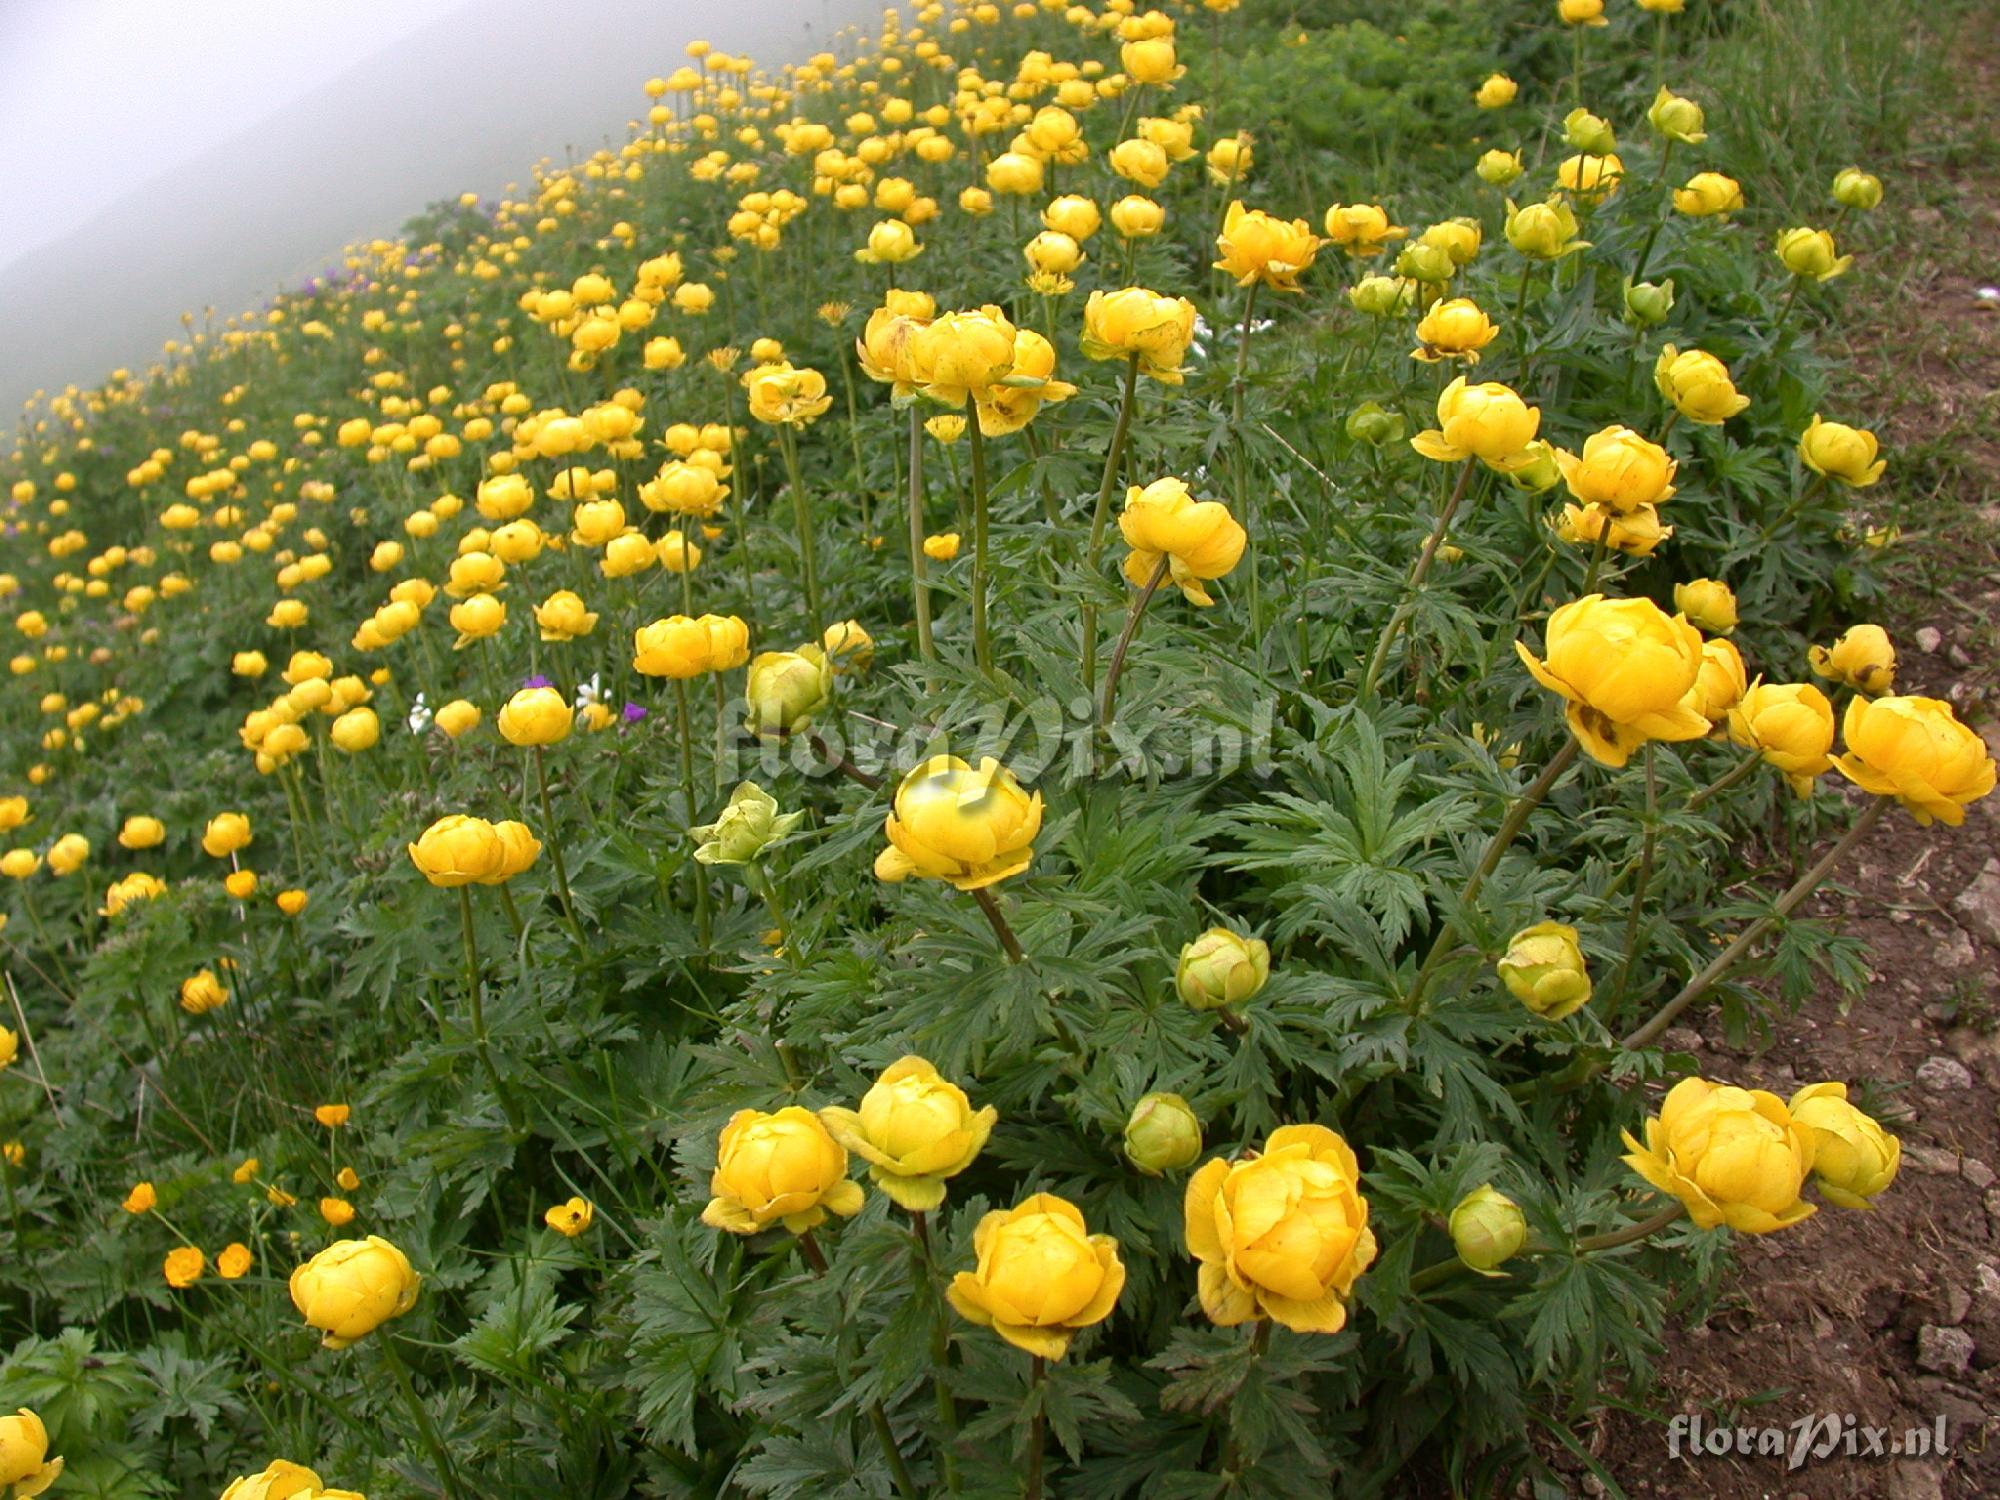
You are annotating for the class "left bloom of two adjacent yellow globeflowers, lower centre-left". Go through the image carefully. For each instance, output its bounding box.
[702,1104,862,1234]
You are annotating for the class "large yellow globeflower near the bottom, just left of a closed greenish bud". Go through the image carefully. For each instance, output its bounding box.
[1184,1124,1376,1334]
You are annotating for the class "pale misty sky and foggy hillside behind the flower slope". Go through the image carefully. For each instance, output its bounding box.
[0,0,882,420]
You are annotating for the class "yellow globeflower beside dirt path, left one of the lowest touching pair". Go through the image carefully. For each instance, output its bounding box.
[1622,1078,1818,1234]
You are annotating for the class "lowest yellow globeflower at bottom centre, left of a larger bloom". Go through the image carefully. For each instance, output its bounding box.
[946,1192,1126,1360]
